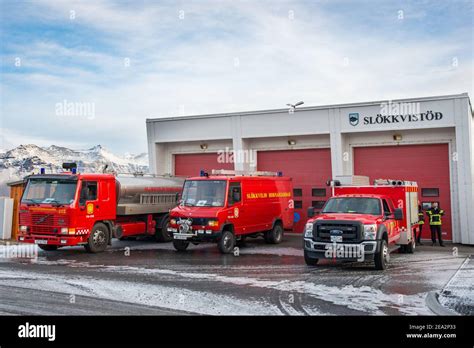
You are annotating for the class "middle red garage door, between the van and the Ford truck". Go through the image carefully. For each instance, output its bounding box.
[257,149,331,233]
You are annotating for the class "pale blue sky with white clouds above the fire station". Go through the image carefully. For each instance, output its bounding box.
[0,0,474,153]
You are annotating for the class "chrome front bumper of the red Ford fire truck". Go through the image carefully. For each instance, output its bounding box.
[303,238,380,261]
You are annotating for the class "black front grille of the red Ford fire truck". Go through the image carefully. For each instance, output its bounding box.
[313,221,362,243]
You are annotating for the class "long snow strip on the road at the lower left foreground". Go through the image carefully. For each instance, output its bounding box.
[0,270,281,315]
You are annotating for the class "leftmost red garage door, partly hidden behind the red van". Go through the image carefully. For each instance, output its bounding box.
[174,153,234,176]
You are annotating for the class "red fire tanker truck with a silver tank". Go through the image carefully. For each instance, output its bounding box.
[18,166,184,253]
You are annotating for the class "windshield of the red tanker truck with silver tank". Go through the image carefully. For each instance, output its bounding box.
[21,179,77,205]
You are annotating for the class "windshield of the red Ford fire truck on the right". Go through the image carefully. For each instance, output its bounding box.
[322,197,382,215]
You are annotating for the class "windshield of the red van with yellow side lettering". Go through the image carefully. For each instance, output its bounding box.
[181,180,227,207]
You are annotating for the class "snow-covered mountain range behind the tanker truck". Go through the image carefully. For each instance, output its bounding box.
[0,144,148,196]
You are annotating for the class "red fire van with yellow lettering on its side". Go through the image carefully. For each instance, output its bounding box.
[168,170,294,254]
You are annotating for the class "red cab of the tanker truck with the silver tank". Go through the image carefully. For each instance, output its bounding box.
[18,172,116,250]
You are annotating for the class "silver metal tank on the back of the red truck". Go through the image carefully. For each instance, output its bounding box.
[116,176,184,215]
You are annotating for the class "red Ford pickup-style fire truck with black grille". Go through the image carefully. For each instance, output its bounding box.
[303,176,418,270]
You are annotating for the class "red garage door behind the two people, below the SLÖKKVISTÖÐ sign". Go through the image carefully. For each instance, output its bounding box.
[354,144,452,240]
